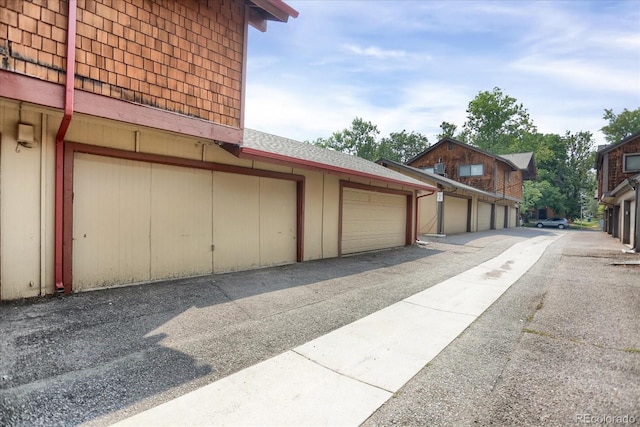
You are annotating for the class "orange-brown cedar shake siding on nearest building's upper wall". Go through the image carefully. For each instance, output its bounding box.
[0,0,246,128]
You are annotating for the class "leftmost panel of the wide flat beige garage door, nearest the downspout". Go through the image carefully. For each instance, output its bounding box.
[73,154,151,290]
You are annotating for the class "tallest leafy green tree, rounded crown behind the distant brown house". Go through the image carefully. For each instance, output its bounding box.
[460,87,536,154]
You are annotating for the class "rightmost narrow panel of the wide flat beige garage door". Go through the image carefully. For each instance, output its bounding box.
[260,178,297,266]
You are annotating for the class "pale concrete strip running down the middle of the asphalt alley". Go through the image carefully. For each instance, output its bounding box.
[116,234,560,426]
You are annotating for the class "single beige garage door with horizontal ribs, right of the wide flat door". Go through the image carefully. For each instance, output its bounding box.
[342,188,407,254]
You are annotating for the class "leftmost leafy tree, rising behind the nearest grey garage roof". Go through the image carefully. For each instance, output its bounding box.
[313,117,380,161]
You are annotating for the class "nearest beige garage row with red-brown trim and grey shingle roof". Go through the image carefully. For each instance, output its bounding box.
[0,101,435,300]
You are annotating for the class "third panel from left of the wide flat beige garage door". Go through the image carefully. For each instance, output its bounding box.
[213,172,260,273]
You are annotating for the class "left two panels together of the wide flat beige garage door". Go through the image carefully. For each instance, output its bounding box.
[73,154,213,290]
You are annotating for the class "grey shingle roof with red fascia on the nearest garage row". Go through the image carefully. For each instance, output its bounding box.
[232,129,437,192]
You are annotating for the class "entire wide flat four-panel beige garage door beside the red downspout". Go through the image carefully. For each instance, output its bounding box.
[73,153,297,290]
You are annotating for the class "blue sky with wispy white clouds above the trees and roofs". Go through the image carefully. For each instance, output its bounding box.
[245,0,640,144]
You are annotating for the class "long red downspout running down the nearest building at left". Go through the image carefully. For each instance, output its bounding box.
[55,0,77,293]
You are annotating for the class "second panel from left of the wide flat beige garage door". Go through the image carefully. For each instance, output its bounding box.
[151,164,213,279]
